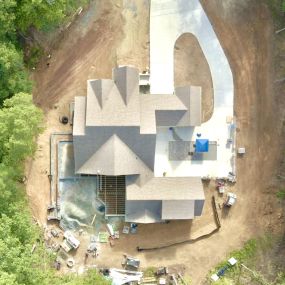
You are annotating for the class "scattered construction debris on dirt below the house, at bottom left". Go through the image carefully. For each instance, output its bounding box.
[45,221,190,285]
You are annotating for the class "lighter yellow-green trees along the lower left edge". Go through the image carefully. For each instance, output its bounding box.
[0,93,109,285]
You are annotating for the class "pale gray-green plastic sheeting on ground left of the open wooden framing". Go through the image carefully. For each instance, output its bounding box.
[58,142,105,230]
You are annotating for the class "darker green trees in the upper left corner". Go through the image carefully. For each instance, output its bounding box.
[0,0,88,102]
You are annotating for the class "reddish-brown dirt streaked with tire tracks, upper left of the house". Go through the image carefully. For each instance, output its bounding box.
[34,0,123,109]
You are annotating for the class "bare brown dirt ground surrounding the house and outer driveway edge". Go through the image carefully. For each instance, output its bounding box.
[27,0,282,284]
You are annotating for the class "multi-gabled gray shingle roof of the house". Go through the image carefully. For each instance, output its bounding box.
[73,66,205,222]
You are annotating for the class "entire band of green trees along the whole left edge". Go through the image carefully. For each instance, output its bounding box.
[0,0,110,285]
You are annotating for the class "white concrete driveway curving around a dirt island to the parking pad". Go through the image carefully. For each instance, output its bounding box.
[150,0,235,177]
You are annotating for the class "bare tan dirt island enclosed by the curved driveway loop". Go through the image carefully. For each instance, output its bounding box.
[174,33,214,122]
